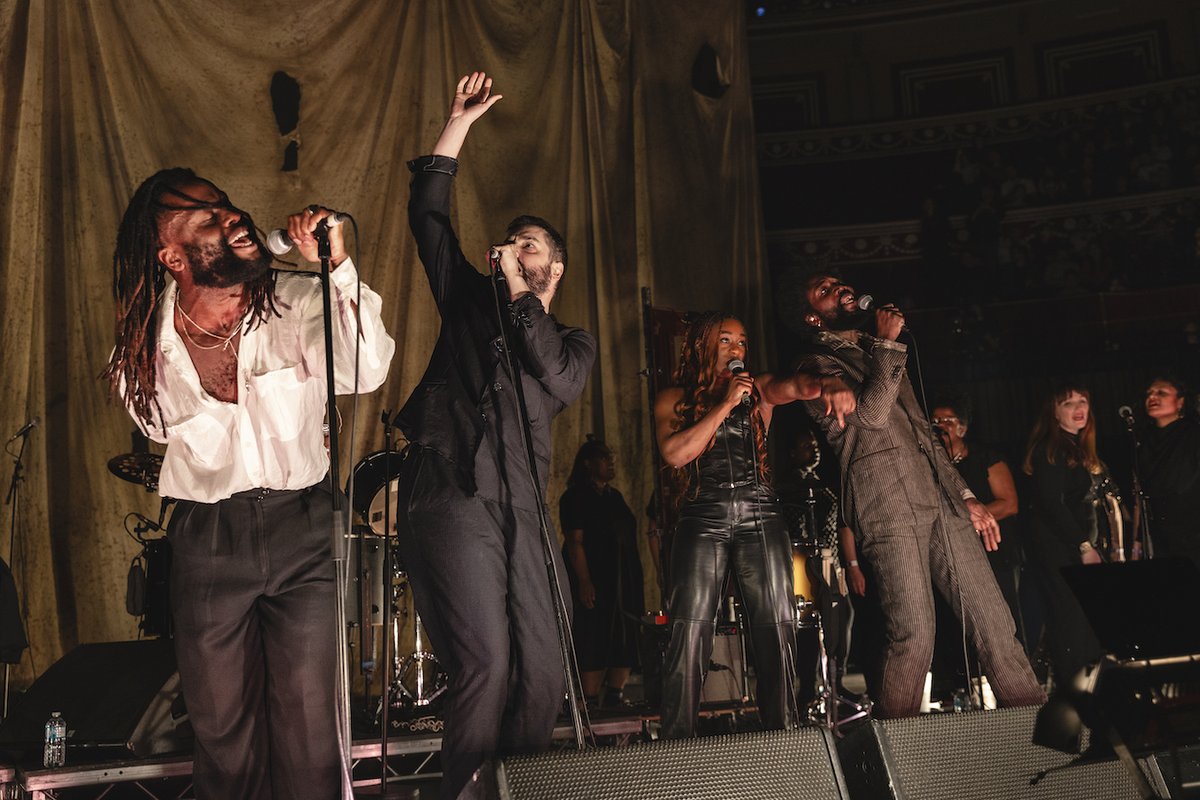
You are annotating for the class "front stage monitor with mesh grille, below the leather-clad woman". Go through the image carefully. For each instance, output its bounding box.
[496,728,848,800]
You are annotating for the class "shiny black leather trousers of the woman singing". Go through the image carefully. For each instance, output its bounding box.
[661,486,797,739]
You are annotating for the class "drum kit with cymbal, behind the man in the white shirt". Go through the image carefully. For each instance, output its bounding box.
[108,448,446,723]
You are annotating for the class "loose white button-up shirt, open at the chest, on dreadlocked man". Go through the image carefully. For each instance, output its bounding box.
[134,259,396,503]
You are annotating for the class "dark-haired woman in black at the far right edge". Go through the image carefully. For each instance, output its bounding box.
[1138,377,1200,565]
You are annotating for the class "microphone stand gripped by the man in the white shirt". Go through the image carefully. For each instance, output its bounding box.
[313,225,358,800]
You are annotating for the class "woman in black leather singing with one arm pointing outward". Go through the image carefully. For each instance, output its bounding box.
[654,312,854,739]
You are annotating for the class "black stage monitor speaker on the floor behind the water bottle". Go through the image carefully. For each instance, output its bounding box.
[0,639,192,764]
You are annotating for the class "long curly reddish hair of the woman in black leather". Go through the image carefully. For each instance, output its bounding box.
[666,311,770,509]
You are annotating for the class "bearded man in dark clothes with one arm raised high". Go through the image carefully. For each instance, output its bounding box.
[397,72,596,798]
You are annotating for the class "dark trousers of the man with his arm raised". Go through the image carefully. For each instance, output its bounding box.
[398,445,570,799]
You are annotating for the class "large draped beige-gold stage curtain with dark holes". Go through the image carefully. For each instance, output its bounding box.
[0,0,768,684]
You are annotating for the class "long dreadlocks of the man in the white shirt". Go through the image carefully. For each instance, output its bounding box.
[101,167,280,427]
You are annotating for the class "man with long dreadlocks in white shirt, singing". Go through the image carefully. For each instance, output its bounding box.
[104,168,395,800]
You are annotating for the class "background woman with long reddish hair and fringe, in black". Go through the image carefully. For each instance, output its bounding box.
[1022,384,1104,686]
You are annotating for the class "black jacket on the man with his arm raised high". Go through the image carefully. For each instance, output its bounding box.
[397,156,596,501]
